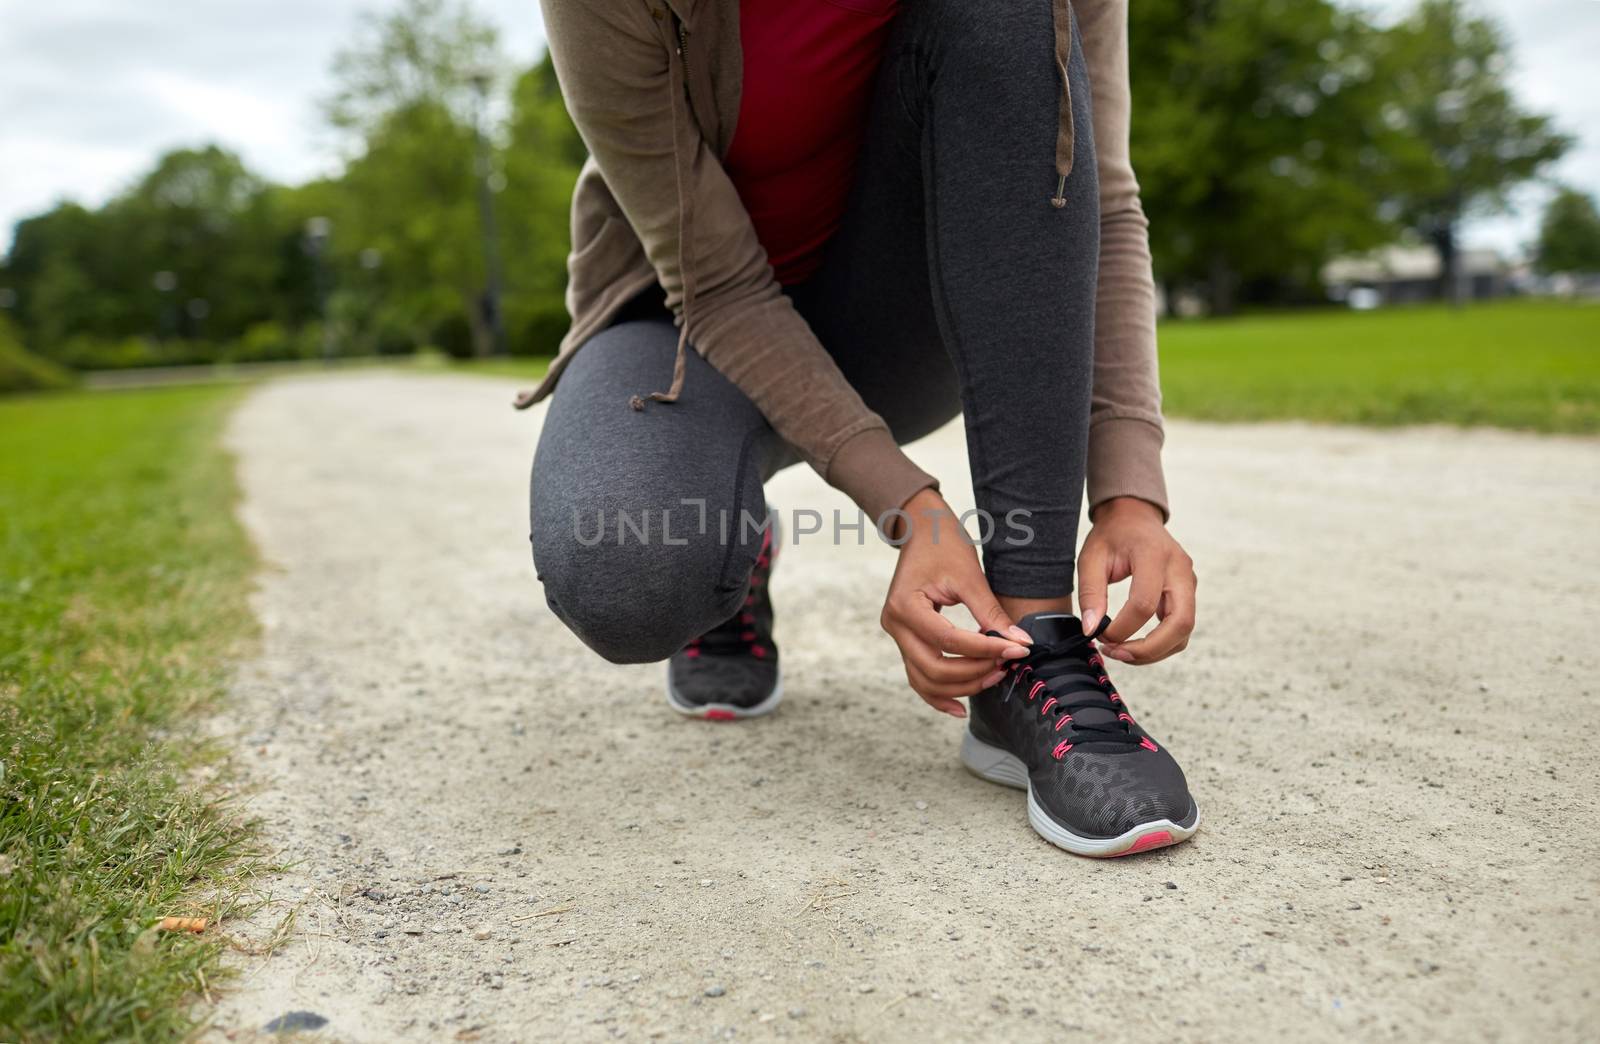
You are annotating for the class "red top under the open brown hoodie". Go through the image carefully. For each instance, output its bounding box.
[723,0,899,285]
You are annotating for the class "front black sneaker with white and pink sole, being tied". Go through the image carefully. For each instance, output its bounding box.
[962,613,1200,857]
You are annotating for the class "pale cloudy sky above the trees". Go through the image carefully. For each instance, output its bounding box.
[0,0,1600,256]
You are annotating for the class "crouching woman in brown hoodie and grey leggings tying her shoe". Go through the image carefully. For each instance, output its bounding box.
[518,0,1198,855]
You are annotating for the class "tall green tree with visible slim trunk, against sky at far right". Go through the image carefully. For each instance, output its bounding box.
[1384,0,1571,303]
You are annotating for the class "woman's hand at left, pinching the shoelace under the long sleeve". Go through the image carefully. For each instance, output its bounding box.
[878,490,1029,717]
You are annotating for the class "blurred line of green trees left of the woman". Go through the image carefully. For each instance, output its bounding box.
[0,0,584,368]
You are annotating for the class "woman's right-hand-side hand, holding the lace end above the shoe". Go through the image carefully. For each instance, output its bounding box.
[1078,496,1197,663]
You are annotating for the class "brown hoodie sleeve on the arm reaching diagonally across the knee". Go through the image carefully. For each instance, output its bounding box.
[542,0,936,519]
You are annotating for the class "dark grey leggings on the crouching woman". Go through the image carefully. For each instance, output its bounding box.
[531,0,1099,663]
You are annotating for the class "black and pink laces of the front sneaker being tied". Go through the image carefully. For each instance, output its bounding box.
[986,616,1158,761]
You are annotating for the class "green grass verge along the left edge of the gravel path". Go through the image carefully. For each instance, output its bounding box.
[0,387,259,1041]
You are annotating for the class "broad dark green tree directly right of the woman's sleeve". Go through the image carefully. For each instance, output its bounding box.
[1130,0,1390,312]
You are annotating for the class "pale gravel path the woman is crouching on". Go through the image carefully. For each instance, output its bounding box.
[218,373,1600,1041]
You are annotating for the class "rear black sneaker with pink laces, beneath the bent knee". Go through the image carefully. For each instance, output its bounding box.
[667,520,784,721]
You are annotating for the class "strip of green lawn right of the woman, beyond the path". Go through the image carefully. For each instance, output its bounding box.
[1162,301,1600,432]
